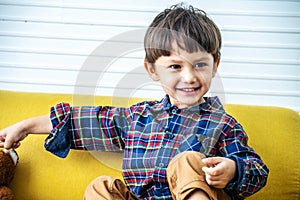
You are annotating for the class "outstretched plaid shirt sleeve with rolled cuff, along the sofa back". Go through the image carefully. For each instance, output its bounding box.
[45,103,131,157]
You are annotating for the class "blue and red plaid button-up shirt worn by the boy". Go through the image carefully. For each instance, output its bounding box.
[45,96,268,199]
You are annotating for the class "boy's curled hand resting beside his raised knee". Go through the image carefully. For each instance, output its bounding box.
[202,157,236,188]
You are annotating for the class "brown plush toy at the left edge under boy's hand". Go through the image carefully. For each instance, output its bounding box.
[0,149,19,200]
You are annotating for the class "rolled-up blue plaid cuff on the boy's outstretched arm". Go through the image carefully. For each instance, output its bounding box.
[44,103,71,158]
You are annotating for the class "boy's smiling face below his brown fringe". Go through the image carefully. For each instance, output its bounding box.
[145,48,219,108]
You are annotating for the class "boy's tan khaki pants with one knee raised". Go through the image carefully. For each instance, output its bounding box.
[84,151,230,200]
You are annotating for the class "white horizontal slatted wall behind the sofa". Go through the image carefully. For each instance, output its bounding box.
[0,0,300,112]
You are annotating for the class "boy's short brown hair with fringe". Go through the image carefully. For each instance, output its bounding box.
[144,4,222,63]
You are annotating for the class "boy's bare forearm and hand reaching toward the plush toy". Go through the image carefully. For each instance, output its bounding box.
[0,114,52,149]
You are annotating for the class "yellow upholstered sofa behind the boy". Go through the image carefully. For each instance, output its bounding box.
[0,91,300,200]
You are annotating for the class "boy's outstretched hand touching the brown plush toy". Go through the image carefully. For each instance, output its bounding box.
[0,121,28,149]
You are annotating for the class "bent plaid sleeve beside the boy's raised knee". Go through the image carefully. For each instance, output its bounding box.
[210,123,269,197]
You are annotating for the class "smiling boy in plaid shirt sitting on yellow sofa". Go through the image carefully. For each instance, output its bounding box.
[0,5,268,199]
